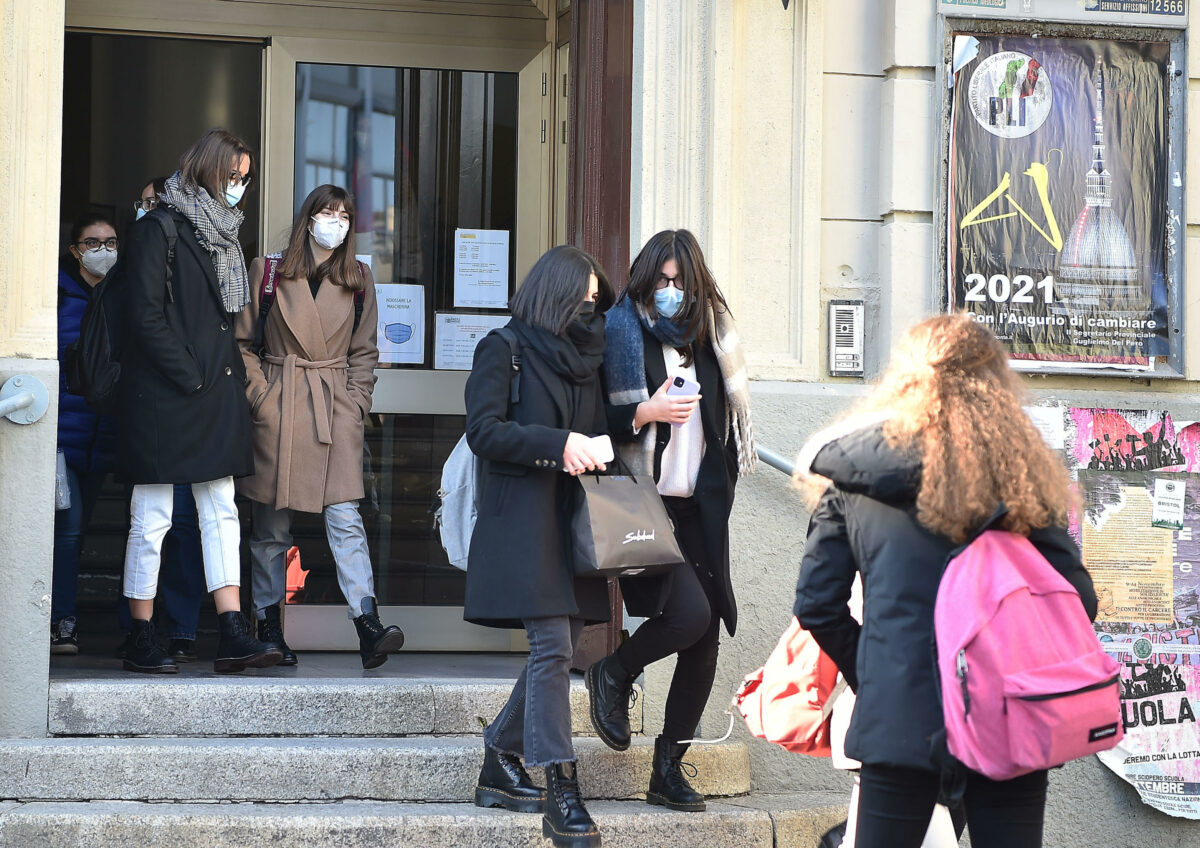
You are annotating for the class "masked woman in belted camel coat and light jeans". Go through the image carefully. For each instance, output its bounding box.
[236,185,404,668]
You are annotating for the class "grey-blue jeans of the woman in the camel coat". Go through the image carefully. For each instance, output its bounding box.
[250,500,374,619]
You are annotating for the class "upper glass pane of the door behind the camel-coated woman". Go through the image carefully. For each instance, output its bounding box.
[293,64,517,368]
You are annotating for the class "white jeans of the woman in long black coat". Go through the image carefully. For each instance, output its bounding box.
[125,477,241,601]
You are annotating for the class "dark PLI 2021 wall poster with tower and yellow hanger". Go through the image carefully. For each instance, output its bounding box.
[946,35,1183,371]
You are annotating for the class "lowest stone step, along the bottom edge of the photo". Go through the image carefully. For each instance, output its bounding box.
[0,794,845,848]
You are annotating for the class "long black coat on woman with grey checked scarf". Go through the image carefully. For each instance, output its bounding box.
[116,206,254,483]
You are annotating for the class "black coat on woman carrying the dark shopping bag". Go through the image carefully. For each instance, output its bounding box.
[463,333,608,629]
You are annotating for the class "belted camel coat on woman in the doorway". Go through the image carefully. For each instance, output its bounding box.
[236,257,379,512]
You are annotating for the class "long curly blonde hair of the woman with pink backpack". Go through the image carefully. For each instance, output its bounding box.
[806,314,1070,542]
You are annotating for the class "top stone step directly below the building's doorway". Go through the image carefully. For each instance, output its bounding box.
[49,674,642,736]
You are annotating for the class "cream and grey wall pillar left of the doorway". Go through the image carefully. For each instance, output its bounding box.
[0,0,62,738]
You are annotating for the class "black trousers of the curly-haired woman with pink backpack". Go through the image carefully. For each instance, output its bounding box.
[854,765,1046,848]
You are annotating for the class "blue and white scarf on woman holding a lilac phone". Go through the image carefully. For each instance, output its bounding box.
[604,296,757,474]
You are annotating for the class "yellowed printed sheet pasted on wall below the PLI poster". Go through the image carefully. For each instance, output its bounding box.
[1080,474,1175,624]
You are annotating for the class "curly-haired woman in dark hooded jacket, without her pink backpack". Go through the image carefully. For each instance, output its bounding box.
[794,315,1096,848]
